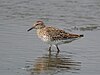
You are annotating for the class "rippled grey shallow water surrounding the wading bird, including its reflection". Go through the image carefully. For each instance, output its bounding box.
[0,0,100,75]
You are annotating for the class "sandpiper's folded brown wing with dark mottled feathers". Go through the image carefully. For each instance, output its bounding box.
[46,27,80,40]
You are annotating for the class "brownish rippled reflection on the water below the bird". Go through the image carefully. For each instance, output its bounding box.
[25,52,81,75]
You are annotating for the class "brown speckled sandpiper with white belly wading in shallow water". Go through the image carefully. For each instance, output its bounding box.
[27,21,83,52]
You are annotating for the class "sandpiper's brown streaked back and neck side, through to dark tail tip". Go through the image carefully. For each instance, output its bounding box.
[39,27,83,41]
